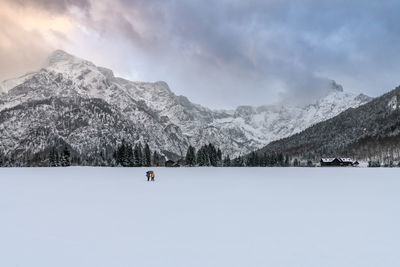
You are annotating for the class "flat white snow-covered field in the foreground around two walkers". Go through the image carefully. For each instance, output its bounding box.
[0,167,400,267]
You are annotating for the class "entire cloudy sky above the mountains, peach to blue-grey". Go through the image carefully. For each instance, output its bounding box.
[0,0,400,108]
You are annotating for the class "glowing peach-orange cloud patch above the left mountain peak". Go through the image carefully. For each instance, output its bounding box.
[0,0,76,80]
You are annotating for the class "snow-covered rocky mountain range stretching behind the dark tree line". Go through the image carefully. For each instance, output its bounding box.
[0,50,370,157]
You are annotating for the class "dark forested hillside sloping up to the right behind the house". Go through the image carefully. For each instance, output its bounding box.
[257,87,400,162]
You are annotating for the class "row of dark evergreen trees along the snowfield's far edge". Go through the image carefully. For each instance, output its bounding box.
[0,140,400,167]
